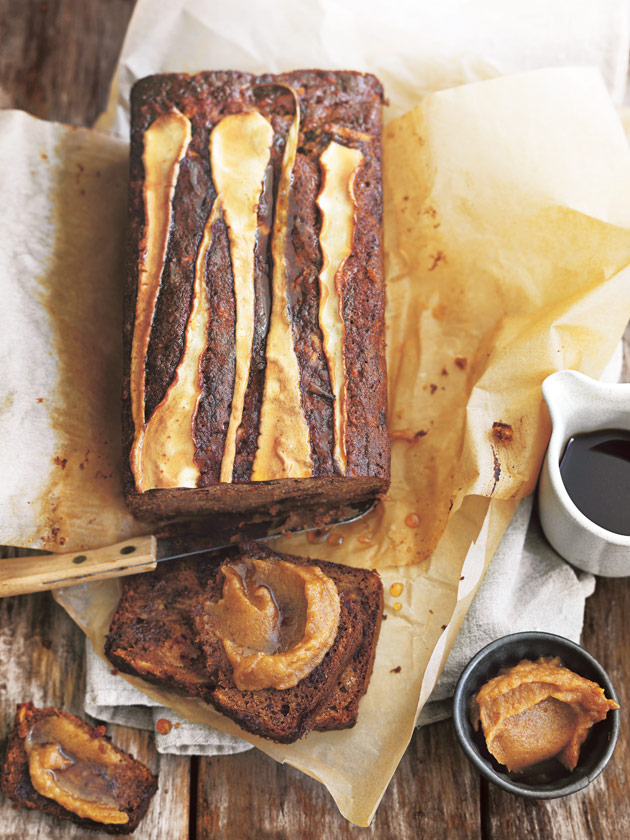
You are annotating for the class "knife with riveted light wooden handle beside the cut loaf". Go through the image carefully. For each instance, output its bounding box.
[0,500,374,598]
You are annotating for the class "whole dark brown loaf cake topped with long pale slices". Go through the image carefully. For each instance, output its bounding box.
[123,70,390,518]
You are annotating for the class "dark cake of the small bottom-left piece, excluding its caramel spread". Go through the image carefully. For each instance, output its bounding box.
[0,703,158,834]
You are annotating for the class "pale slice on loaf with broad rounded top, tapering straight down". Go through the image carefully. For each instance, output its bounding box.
[216,111,273,482]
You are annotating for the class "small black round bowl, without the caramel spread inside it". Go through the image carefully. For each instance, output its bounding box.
[453,632,619,799]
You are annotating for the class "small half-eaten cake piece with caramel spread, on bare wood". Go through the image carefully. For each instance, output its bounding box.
[1,703,158,834]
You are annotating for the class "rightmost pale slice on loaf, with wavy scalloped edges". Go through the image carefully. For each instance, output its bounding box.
[317,141,363,475]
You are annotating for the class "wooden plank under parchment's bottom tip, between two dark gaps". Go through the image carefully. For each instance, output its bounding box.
[197,721,481,840]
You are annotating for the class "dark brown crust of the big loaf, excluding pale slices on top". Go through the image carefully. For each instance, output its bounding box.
[123,70,389,518]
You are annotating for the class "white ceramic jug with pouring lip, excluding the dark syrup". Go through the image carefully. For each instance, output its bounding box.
[538,370,630,577]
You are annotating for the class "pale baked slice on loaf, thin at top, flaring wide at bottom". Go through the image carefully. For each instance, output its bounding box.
[251,91,313,481]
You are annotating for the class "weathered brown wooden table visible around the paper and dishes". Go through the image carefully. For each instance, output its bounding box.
[0,0,630,840]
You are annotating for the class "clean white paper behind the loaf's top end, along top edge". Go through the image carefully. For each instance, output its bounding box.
[99,0,630,131]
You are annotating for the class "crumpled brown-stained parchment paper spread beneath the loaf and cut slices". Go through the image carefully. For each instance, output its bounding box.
[0,19,630,825]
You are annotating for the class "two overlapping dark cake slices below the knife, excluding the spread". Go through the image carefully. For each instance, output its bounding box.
[105,541,383,743]
